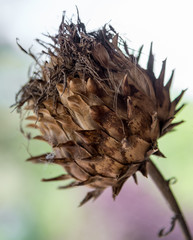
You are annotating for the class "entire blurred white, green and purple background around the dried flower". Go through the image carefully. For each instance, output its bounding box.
[0,0,193,240]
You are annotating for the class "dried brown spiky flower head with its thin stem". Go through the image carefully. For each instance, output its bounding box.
[16,10,191,239]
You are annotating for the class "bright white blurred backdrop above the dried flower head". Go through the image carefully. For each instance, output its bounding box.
[0,0,193,98]
